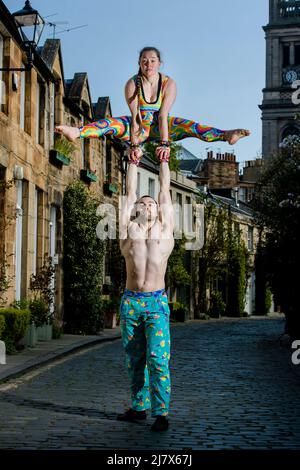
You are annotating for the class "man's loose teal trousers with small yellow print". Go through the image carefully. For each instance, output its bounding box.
[120,289,171,416]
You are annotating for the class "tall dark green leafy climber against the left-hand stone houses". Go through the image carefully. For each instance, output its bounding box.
[63,181,105,334]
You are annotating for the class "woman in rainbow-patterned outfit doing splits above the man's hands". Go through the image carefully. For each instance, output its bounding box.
[55,47,250,164]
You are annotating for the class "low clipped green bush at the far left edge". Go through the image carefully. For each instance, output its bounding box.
[0,308,30,353]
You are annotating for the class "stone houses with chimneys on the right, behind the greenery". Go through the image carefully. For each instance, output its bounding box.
[180,147,263,315]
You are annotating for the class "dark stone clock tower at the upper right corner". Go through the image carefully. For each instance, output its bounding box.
[259,0,300,158]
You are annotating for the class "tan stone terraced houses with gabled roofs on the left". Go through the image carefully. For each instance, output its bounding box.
[0,2,122,324]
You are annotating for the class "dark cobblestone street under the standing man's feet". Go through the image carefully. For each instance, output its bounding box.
[0,318,300,450]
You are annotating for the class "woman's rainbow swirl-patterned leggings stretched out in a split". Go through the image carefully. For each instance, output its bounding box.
[79,112,225,142]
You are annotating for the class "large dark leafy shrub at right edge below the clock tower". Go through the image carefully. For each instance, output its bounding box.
[254,135,300,339]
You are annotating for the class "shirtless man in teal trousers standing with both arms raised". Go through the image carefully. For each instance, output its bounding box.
[118,155,174,431]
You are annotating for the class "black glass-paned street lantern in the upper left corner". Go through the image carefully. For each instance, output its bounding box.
[0,0,45,72]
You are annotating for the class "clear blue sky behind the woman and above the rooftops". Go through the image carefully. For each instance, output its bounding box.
[4,0,269,162]
